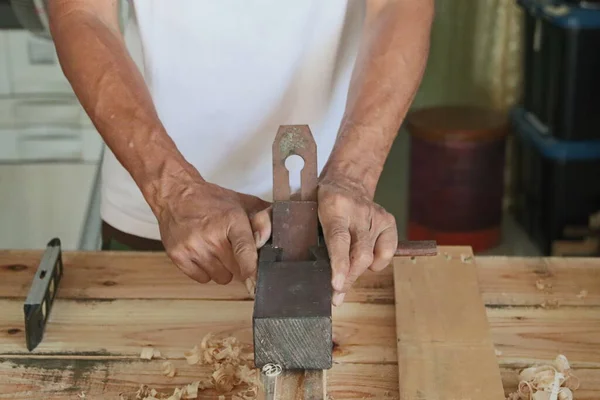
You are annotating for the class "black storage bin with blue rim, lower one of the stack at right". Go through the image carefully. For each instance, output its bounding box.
[511,108,600,255]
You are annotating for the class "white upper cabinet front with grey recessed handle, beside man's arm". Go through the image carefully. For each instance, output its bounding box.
[5,30,73,95]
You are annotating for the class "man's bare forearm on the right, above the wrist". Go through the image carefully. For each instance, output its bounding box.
[321,0,434,198]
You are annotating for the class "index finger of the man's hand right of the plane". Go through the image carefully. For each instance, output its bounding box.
[322,217,351,292]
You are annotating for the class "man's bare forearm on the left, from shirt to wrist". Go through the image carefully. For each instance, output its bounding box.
[50,0,195,212]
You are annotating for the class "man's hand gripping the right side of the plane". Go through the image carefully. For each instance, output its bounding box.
[318,173,398,306]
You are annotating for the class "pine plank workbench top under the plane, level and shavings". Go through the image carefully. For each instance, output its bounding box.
[0,248,600,400]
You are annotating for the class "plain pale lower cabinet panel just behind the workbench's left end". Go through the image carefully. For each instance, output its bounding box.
[0,163,98,250]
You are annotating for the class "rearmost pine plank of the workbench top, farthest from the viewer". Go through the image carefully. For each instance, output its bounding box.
[0,247,600,306]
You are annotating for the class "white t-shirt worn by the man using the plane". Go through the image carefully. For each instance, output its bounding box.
[101,0,364,239]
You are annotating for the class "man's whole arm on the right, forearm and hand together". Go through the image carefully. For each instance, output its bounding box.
[319,0,434,305]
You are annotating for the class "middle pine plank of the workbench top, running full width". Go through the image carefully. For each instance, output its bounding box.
[0,300,600,367]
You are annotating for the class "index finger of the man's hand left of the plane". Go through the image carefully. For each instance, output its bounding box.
[227,215,258,279]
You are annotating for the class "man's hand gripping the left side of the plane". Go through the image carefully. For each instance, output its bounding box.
[155,178,271,285]
